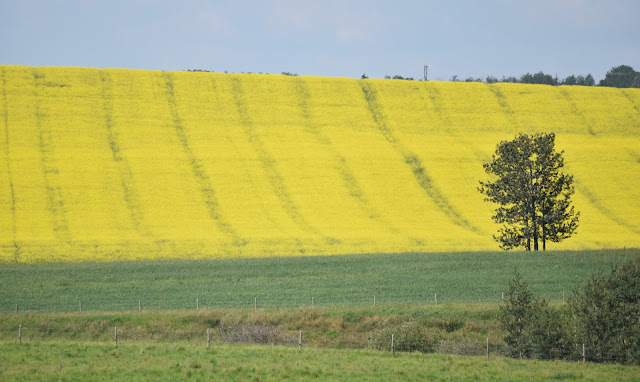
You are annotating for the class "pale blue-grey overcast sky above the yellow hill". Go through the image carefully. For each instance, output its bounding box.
[0,0,640,80]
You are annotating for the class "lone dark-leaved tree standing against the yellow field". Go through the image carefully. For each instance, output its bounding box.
[478,133,580,251]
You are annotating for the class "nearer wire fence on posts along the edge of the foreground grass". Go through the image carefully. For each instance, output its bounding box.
[0,324,625,363]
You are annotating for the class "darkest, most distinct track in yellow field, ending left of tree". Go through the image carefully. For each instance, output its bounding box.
[359,80,480,232]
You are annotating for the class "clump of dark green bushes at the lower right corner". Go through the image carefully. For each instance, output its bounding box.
[500,258,640,364]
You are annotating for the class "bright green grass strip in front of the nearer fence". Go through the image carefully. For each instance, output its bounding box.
[0,342,640,381]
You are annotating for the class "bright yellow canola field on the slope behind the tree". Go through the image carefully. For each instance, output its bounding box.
[0,66,640,263]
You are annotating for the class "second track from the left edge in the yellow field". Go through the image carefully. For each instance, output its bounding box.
[33,69,71,243]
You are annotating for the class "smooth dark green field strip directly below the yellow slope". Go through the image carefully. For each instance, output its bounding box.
[0,249,640,313]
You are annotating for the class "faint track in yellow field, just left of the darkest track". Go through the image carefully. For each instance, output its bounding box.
[295,78,398,233]
